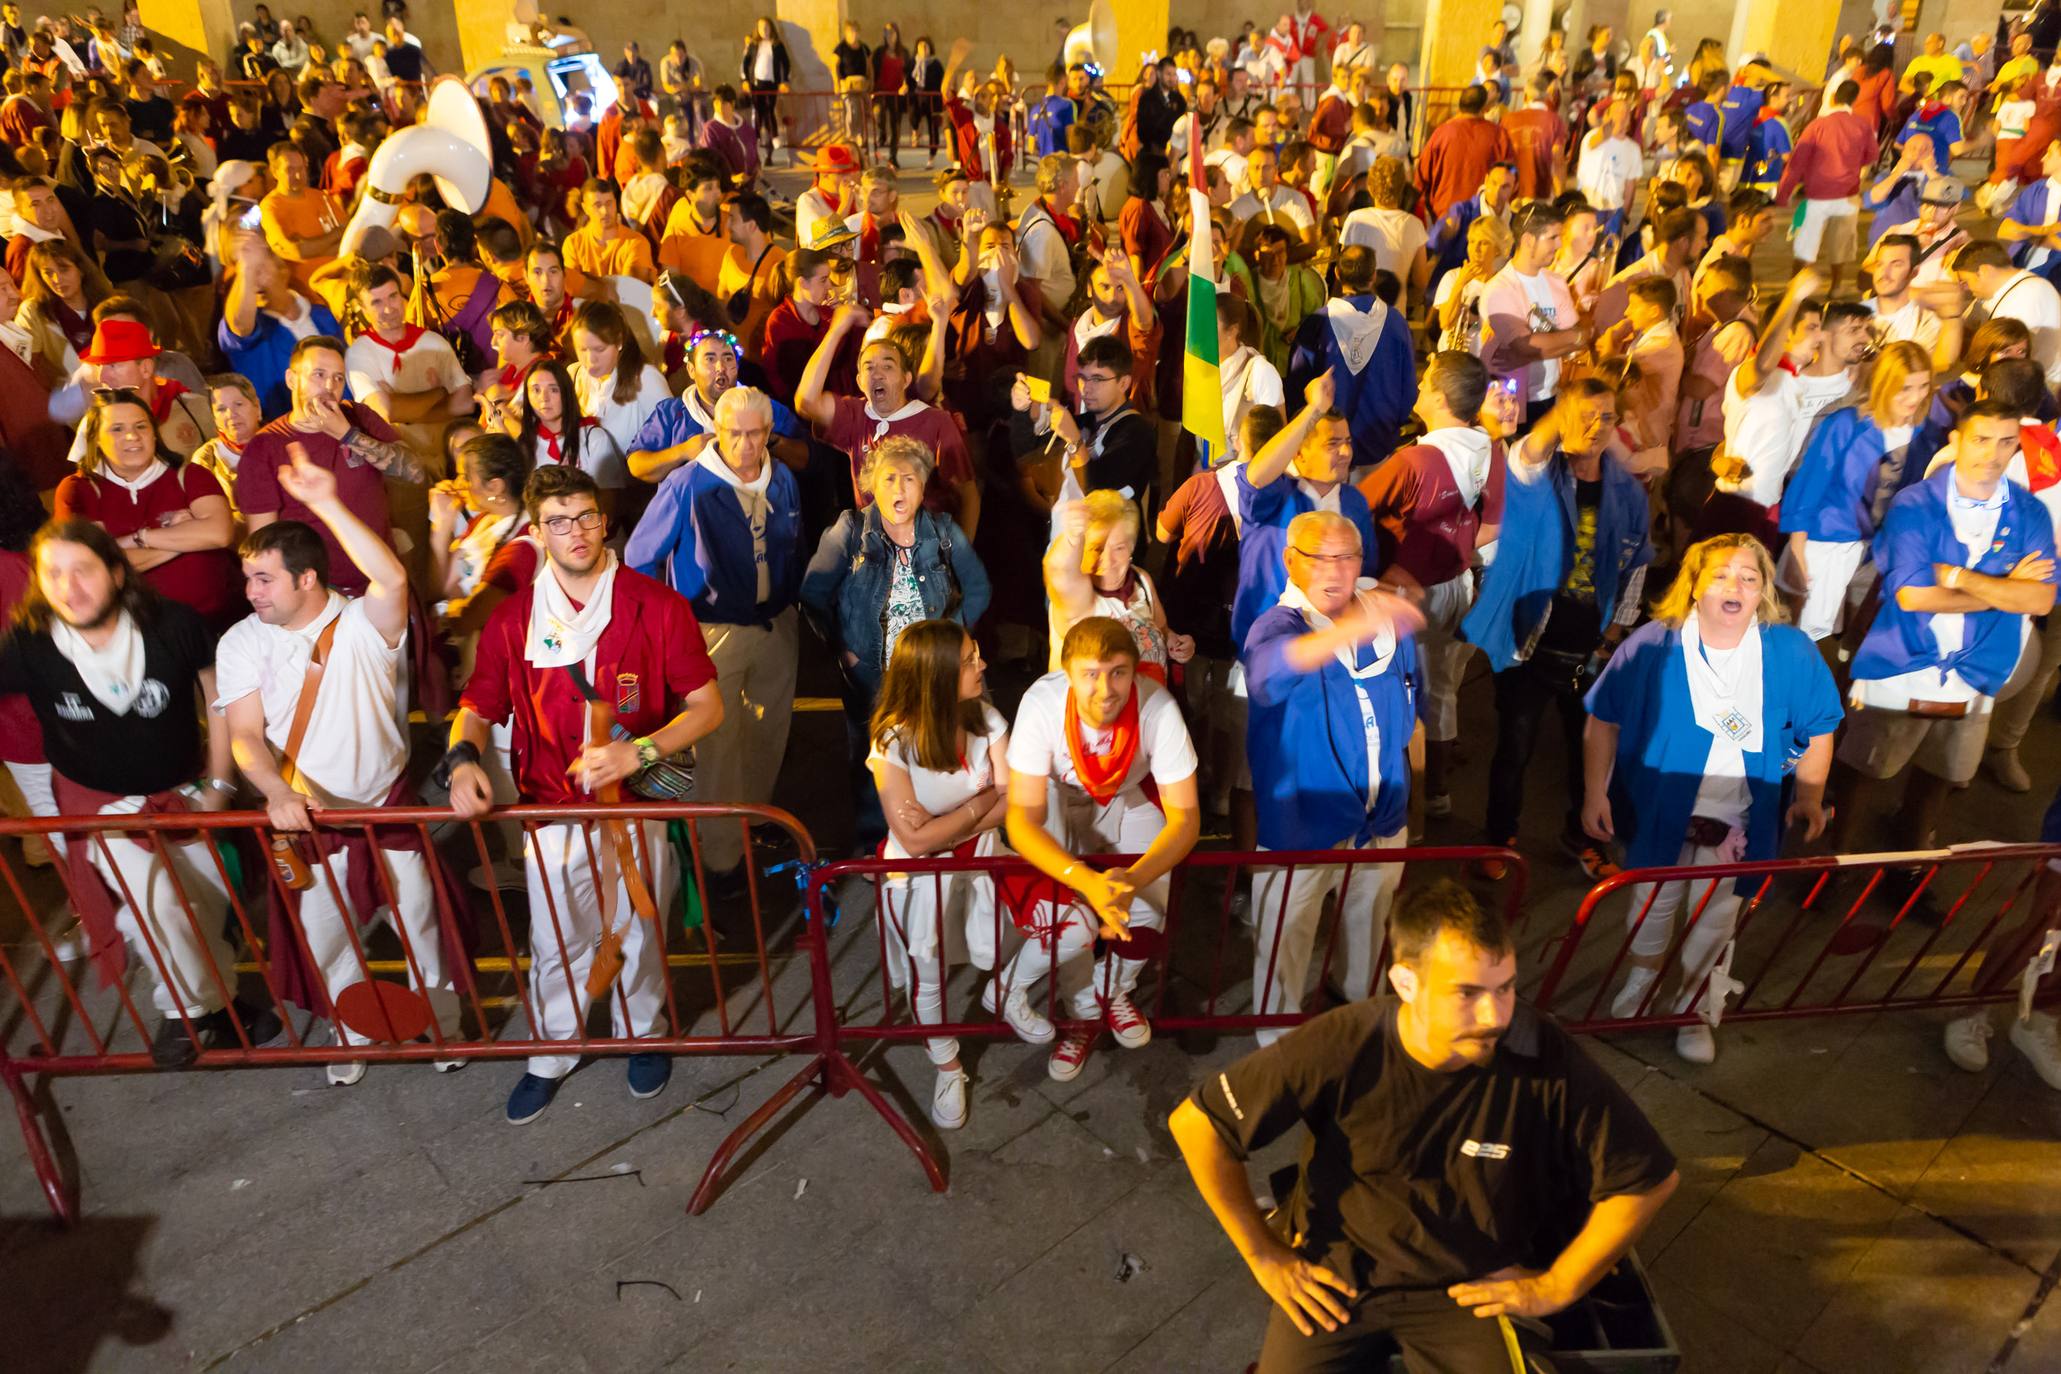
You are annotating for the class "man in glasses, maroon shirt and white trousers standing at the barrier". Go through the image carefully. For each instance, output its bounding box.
[439,466,723,1125]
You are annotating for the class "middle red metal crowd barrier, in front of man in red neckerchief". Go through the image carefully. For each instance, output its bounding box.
[808,847,1529,1191]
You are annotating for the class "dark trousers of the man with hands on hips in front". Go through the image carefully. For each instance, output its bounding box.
[1255,1290,1554,1374]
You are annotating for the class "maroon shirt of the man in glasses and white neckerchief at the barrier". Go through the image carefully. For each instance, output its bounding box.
[460,569,715,805]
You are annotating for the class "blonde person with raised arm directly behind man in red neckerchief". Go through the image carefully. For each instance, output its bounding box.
[1045,490,1195,686]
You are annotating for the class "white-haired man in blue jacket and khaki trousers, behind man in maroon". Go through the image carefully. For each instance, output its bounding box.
[622,387,808,892]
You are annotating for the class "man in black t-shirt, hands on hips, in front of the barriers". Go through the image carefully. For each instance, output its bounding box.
[1169,882,1678,1374]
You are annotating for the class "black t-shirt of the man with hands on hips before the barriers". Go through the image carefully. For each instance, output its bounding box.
[1191,999,1676,1290]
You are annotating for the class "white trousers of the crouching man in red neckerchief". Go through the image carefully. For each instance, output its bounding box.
[1006,787,1169,1020]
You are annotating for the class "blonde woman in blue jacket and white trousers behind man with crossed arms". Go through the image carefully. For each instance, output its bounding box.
[1777,340,1933,641]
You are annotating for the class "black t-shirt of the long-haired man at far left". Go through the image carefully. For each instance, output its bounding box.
[0,602,214,797]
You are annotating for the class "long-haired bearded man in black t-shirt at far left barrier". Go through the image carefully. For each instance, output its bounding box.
[0,519,280,1069]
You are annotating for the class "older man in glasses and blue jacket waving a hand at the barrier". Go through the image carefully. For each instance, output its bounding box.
[1243,511,1424,1044]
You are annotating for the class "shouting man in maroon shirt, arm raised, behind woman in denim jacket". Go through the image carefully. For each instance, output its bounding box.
[793,305,981,540]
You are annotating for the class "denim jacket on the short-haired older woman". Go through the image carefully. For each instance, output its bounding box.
[802,507,989,690]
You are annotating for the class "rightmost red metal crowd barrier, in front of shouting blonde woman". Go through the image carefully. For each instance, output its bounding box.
[1535,845,2061,1034]
